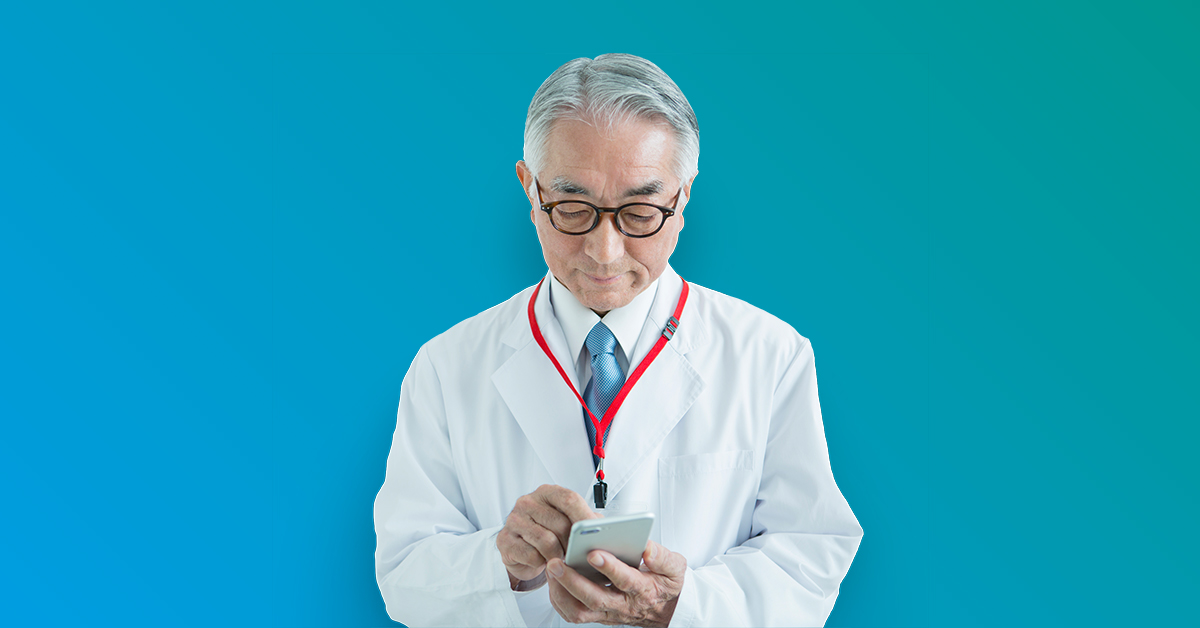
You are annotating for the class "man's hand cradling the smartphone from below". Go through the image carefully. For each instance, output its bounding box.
[546,540,688,626]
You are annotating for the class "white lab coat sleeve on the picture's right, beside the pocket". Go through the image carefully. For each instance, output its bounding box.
[671,340,863,626]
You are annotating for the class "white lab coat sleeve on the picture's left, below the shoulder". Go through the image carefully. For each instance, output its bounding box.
[374,347,524,627]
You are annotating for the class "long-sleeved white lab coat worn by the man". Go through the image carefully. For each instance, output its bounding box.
[374,268,863,627]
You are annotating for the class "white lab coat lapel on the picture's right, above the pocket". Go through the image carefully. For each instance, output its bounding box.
[605,267,706,498]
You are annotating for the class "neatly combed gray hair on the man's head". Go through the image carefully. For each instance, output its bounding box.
[524,54,700,180]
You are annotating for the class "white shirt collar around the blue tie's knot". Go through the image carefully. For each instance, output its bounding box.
[550,274,659,361]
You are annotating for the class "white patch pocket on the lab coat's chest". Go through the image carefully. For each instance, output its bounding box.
[659,449,755,568]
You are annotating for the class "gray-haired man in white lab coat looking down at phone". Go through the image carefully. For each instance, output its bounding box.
[376,54,863,626]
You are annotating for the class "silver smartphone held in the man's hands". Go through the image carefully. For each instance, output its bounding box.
[563,513,654,585]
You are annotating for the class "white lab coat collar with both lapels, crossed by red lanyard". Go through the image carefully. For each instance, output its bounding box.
[492,267,706,502]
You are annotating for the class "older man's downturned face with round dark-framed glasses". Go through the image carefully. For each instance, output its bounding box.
[517,115,691,315]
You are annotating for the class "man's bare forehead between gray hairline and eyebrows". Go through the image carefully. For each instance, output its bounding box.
[542,119,674,187]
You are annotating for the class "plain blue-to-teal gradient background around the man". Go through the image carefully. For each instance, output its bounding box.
[0,1,1200,627]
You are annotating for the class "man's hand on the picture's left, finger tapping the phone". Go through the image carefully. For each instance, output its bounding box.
[496,484,602,588]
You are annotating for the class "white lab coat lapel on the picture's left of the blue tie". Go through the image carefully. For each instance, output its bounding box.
[492,275,594,496]
